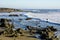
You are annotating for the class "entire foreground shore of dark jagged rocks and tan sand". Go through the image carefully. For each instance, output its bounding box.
[0,19,59,40]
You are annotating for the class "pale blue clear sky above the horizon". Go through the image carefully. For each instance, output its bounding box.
[0,0,60,9]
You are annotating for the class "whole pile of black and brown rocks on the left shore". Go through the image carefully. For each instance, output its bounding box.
[0,19,17,37]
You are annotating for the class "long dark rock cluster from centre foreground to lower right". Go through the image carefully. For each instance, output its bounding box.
[27,26,58,40]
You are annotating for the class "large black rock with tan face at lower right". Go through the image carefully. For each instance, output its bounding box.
[37,26,58,40]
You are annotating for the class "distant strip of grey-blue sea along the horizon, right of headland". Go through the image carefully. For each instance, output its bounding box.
[24,9,60,13]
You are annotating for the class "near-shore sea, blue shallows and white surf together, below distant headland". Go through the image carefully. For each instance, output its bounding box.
[0,12,60,37]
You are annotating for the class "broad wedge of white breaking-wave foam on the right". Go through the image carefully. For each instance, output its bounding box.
[26,12,60,24]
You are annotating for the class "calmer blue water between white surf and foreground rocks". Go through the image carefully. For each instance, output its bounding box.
[0,14,60,30]
